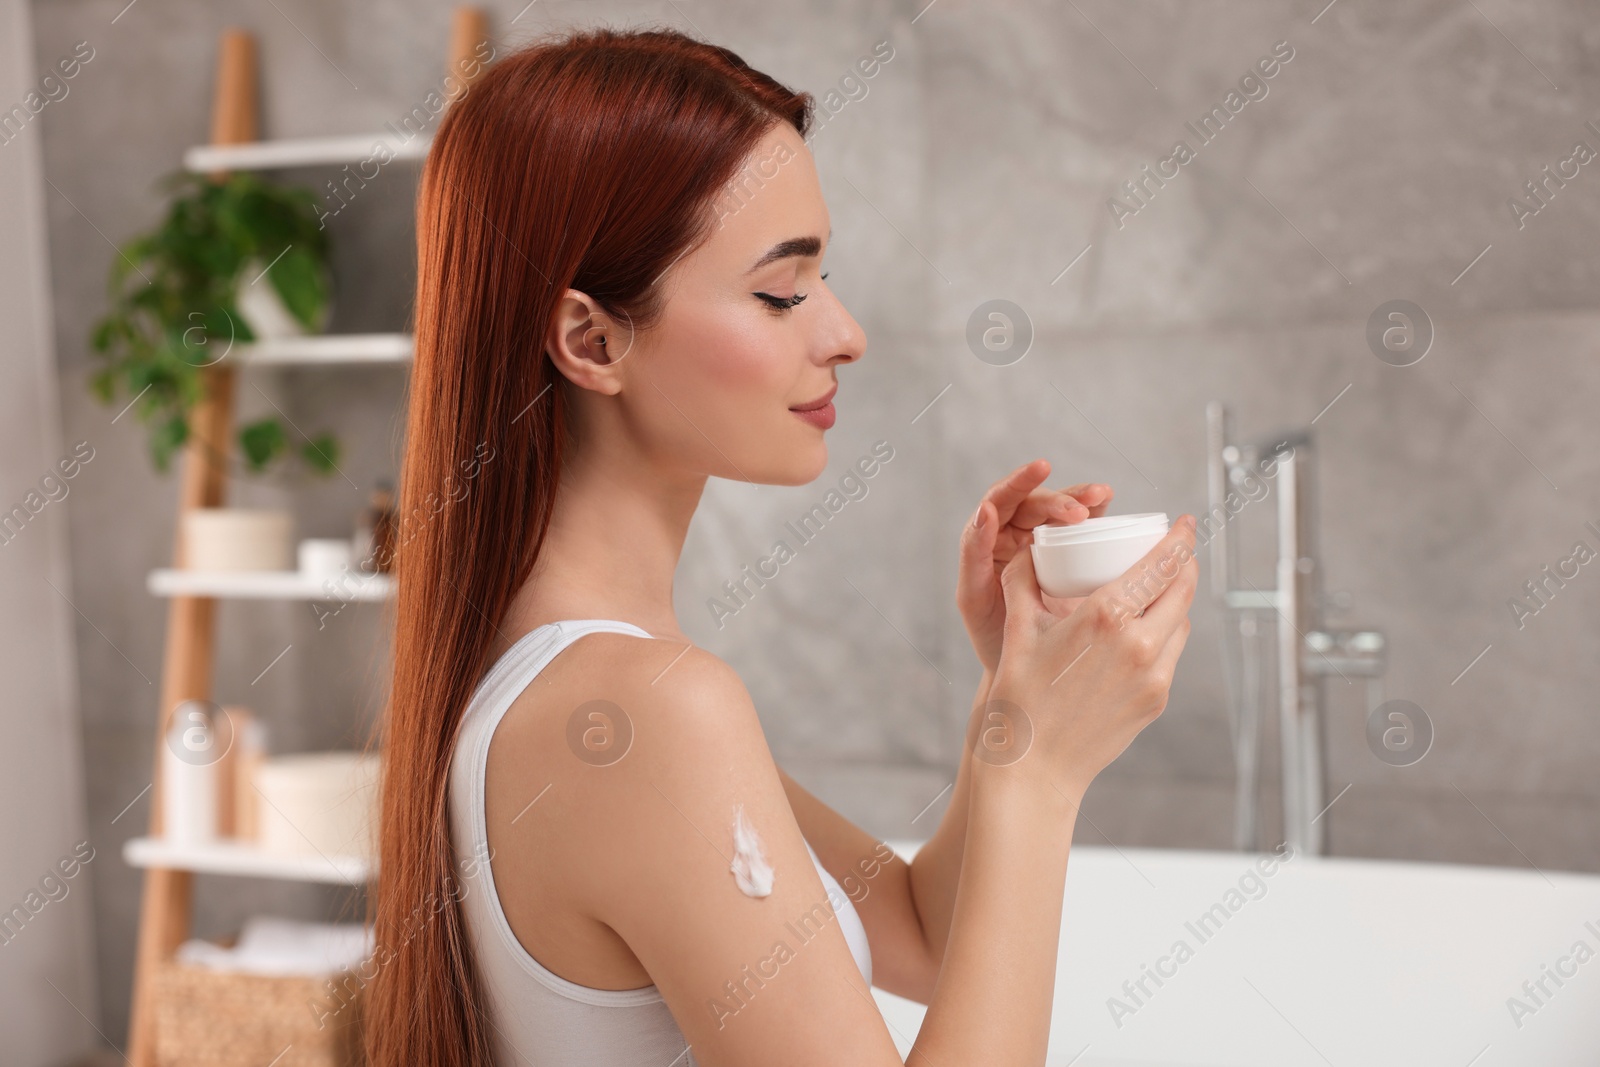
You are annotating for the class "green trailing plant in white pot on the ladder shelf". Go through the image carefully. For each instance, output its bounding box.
[90,171,339,475]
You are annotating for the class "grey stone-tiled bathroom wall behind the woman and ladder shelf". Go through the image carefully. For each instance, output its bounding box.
[0,0,1600,1062]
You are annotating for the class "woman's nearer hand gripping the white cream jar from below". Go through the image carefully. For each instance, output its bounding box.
[973,515,1200,803]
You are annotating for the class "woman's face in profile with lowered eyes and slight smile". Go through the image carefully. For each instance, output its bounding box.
[572,123,867,485]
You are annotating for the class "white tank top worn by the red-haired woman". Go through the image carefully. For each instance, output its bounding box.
[450,619,872,1067]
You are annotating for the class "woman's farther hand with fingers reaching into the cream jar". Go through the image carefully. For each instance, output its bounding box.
[955,459,1112,673]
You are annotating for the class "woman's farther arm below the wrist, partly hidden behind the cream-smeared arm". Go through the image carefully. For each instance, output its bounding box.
[782,669,994,1005]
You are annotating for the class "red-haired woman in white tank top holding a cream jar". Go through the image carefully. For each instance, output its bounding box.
[365,29,1197,1067]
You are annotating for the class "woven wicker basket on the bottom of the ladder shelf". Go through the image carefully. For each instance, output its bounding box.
[154,940,362,1067]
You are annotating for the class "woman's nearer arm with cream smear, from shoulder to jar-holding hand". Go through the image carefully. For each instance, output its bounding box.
[488,523,1197,1067]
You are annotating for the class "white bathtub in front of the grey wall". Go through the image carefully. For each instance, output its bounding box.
[874,841,1600,1067]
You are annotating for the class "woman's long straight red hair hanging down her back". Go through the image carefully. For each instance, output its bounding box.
[362,27,813,1067]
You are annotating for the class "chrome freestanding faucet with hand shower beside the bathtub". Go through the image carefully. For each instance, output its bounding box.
[1195,400,1387,854]
